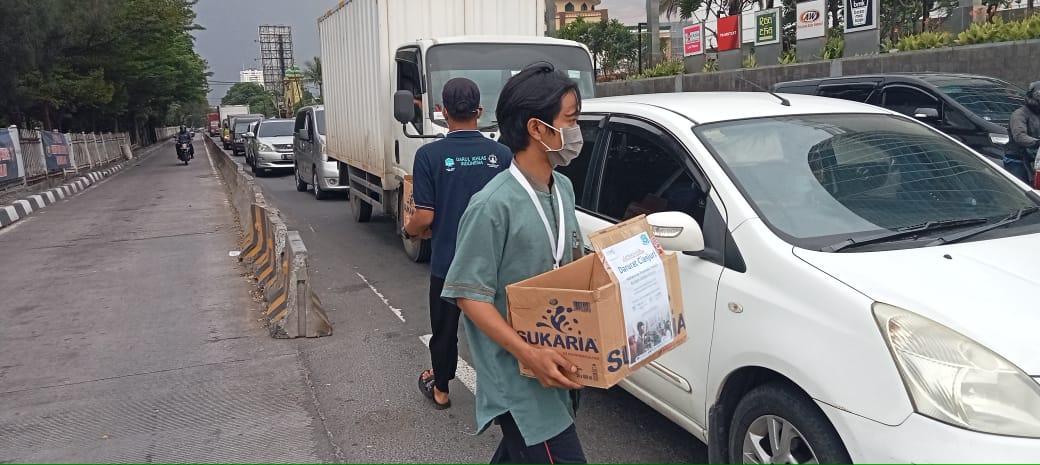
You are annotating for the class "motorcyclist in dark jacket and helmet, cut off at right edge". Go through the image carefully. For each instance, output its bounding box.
[1004,81,1040,185]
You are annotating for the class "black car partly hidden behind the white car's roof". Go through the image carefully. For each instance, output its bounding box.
[774,73,1025,159]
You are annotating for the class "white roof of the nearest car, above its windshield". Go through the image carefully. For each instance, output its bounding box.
[581,92,892,124]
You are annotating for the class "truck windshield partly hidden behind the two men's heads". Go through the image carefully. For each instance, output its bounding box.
[426,44,594,128]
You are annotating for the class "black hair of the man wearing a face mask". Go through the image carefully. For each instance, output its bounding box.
[495,61,581,153]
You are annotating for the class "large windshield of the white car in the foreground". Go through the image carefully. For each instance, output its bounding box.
[695,114,1036,249]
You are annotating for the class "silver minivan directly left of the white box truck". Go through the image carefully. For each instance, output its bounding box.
[292,105,350,200]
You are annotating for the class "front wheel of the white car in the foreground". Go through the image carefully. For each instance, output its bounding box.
[728,382,852,463]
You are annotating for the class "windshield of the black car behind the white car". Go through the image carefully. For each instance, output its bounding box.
[925,76,1025,126]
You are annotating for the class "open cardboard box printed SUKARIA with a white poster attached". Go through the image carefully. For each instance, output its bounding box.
[505,215,686,388]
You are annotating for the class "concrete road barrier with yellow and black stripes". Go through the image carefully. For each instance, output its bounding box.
[206,137,332,338]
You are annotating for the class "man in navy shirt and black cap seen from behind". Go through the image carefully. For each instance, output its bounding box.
[401,78,513,410]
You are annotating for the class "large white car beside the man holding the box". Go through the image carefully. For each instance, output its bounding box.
[558,93,1040,463]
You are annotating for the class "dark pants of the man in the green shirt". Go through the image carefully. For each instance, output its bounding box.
[491,413,588,463]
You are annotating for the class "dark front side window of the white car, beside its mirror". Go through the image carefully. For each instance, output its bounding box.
[597,123,706,224]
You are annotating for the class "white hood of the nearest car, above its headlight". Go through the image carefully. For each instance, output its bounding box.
[795,234,1040,377]
